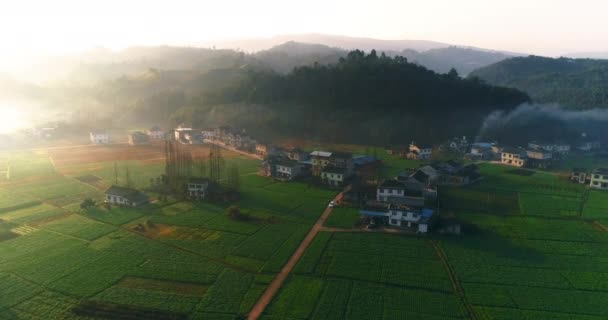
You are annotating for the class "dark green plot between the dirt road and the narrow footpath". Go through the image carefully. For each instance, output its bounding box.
[264,232,465,319]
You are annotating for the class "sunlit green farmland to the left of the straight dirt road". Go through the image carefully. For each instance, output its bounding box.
[0,145,334,319]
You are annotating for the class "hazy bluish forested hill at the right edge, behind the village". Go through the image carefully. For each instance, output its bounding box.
[470,56,608,109]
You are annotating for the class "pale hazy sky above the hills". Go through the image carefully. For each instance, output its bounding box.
[0,0,608,60]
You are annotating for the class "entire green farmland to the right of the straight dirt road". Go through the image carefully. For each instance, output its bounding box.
[264,164,608,320]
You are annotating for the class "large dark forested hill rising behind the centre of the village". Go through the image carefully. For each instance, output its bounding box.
[194,51,529,144]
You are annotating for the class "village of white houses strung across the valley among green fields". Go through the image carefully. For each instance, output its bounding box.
[75,125,608,234]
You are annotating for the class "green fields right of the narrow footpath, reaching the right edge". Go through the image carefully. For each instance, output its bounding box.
[440,165,608,320]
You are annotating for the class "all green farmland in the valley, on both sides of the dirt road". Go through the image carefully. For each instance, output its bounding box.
[0,141,608,320]
